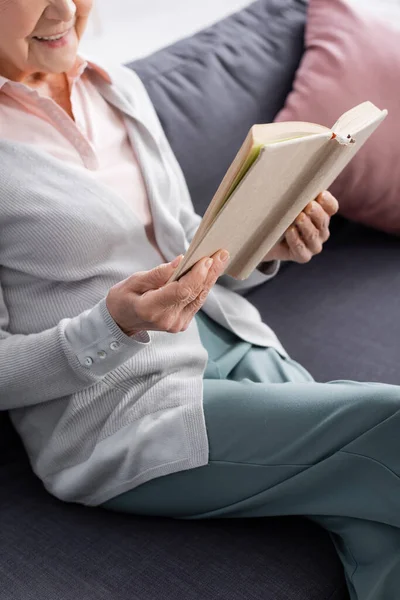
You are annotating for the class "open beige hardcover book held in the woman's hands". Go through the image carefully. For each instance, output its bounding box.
[170,102,388,281]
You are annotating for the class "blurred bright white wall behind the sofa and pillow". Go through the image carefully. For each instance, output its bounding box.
[81,0,400,63]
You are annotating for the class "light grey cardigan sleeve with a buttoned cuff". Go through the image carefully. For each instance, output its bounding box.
[0,287,150,410]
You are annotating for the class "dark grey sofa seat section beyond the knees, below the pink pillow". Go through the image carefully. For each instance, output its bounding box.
[248,217,400,385]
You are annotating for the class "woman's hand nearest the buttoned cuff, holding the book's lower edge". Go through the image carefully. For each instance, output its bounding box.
[106,250,229,336]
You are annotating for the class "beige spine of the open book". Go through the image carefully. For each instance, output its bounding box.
[227,137,354,280]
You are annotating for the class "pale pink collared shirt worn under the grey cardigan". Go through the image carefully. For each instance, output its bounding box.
[0,58,164,260]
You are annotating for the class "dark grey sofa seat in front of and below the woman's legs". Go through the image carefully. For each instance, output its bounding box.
[0,452,346,600]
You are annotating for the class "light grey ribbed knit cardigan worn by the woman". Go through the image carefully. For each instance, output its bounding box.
[0,61,284,504]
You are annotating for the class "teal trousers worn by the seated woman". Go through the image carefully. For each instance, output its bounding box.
[103,313,400,600]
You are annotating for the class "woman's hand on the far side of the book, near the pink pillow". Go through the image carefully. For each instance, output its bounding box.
[262,192,339,263]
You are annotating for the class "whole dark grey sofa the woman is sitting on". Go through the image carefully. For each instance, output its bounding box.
[0,0,400,600]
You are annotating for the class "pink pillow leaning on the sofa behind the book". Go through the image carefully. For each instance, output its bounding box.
[276,0,400,234]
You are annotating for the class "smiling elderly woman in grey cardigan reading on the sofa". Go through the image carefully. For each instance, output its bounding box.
[0,0,400,600]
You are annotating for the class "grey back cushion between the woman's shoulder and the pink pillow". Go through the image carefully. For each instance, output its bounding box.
[128,0,307,214]
